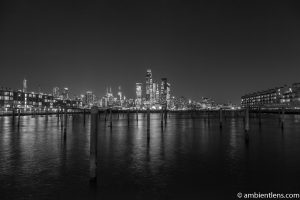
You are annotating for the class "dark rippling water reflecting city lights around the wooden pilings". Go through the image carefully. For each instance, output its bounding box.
[0,114,300,199]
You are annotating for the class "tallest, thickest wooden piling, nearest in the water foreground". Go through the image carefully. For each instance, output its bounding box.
[90,107,98,184]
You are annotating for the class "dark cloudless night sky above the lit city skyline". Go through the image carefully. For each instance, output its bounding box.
[0,0,300,103]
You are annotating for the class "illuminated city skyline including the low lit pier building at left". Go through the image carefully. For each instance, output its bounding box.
[0,69,241,111]
